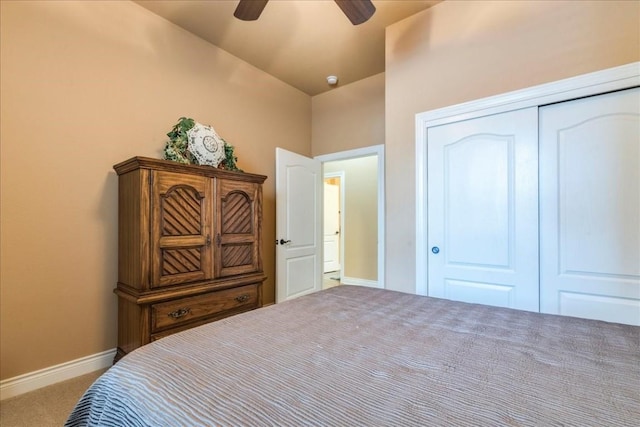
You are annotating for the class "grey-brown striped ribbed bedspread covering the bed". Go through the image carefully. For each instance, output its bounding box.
[66,286,640,427]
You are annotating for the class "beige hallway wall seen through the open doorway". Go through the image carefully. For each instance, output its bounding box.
[323,156,378,281]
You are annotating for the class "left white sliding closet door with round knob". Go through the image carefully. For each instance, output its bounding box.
[427,107,539,311]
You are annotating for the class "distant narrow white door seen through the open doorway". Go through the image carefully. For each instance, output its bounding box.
[324,182,340,273]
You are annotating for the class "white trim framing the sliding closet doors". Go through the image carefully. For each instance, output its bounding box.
[415,62,640,295]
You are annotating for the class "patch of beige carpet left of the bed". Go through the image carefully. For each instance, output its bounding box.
[0,370,105,427]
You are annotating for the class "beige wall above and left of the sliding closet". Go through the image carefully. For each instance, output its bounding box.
[385,0,640,292]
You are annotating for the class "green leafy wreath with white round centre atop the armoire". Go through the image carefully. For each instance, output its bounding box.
[163,117,242,172]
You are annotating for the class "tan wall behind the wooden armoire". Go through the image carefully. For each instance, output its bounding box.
[0,0,311,379]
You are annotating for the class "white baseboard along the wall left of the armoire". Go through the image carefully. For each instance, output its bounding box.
[0,348,116,400]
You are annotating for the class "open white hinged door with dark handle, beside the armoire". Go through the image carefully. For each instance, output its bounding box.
[276,148,322,302]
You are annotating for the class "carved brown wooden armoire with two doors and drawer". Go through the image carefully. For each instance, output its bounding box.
[114,157,266,361]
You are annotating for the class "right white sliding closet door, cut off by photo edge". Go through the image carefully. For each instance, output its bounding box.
[540,88,640,325]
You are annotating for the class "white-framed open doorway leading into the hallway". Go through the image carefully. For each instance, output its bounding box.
[316,145,384,288]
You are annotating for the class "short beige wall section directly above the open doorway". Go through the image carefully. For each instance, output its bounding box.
[311,73,384,156]
